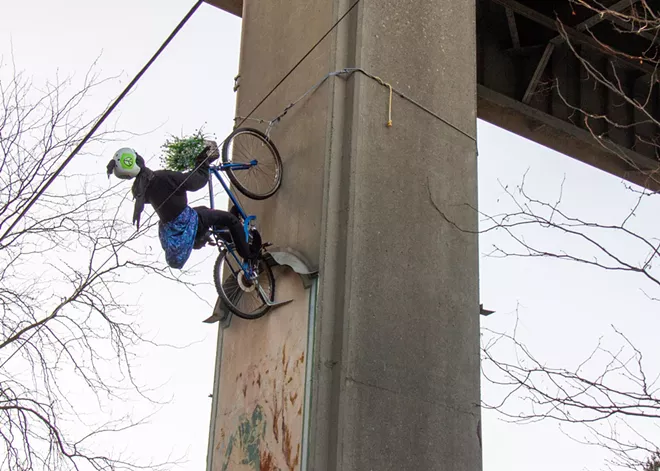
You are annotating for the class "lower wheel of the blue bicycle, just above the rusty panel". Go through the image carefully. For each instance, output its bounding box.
[213,250,275,319]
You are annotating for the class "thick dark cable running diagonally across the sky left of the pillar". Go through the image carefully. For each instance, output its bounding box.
[0,0,204,242]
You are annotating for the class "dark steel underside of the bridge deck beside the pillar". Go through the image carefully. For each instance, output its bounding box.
[207,0,660,190]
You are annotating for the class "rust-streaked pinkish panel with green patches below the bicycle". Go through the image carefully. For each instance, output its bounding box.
[212,272,309,471]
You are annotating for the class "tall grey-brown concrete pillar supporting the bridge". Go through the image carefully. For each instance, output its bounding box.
[210,0,481,471]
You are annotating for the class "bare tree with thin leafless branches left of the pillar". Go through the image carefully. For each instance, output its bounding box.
[0,60,186,471]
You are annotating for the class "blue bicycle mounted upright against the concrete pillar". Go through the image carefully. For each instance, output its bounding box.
[201,128,284,319]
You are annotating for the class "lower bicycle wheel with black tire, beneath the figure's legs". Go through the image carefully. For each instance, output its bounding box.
[213,249,275,320]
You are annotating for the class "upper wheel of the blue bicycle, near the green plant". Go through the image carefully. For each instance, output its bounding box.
[222,128,282,200]
